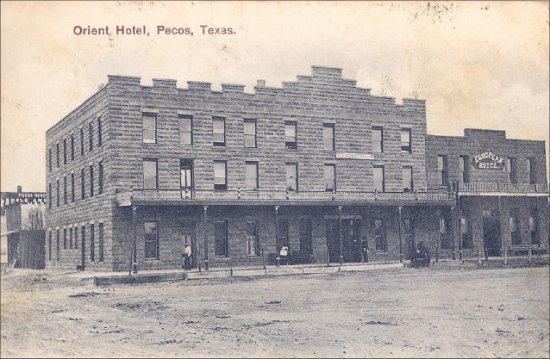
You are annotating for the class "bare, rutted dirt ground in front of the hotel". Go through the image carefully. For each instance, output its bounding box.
[1,267,550,358]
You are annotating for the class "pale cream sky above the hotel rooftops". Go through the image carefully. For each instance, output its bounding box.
[0,1,550,191]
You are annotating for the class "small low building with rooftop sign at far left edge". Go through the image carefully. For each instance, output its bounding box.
[0,186,46,269]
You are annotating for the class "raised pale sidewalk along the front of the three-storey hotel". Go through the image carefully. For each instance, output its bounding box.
[87,261,403,286]
